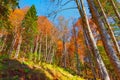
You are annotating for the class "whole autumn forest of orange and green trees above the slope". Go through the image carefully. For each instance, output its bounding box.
[0,0,120,80]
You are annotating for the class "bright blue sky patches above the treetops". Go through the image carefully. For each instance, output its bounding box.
[19,0,90,19]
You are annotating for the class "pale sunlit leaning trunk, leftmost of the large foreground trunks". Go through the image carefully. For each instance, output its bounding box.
[76,0,110,80]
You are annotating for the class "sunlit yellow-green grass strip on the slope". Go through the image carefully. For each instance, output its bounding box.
[21,61,84,80]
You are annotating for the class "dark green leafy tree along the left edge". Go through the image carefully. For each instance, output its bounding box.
[0,0,18,51]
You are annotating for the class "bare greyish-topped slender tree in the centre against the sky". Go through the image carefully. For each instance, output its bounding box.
[59,16,69,68]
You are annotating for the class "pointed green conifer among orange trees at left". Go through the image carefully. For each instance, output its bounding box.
[21,5,38,52]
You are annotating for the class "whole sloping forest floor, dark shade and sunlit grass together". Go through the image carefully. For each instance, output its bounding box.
[0,56,84,80]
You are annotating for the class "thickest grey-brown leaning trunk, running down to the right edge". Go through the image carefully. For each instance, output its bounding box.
[87,0,120,77]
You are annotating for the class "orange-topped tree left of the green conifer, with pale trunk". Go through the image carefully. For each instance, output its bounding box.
[9,9,25,58]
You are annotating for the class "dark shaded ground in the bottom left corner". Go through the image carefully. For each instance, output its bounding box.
[0,59,49,80]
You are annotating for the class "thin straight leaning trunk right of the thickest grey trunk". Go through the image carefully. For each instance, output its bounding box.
[97,0,120,54]
